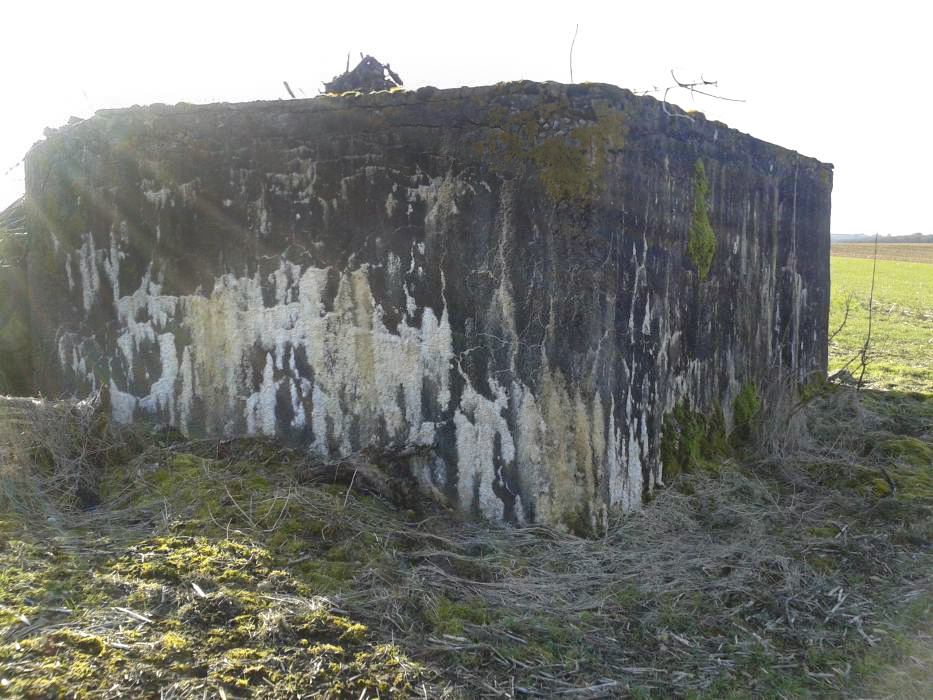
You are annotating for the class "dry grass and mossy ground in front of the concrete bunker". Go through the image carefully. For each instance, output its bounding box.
[0,388,933,699]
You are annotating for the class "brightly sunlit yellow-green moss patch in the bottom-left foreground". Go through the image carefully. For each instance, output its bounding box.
[0,520,422,698]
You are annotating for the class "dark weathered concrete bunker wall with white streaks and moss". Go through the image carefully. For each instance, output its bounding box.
[27,83,832,530]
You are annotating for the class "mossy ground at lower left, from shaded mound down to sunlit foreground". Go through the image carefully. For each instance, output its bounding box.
[0,445,430,699]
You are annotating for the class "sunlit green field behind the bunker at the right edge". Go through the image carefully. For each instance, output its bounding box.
[829,252,933,393]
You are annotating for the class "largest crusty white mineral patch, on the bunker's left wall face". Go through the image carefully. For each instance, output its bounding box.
[91,251,453,453]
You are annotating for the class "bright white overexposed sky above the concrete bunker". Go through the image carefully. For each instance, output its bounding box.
[0,0,933,235]
